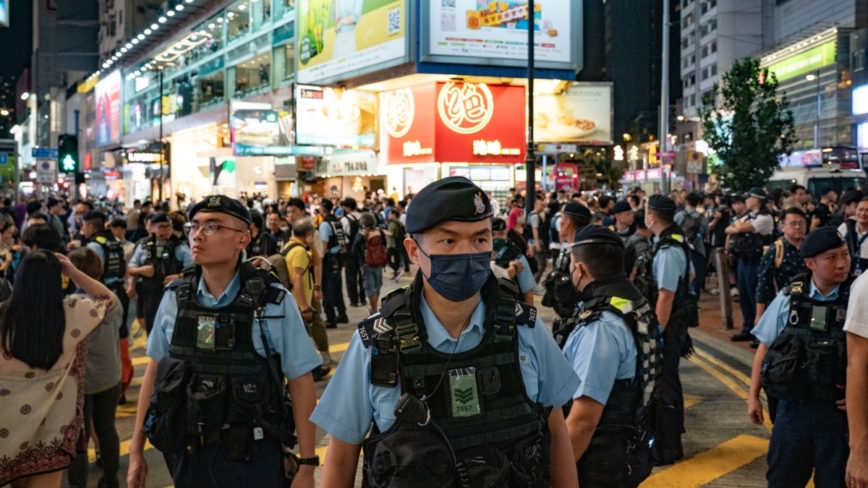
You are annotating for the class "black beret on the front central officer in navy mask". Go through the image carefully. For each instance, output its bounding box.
[405,176,491,234]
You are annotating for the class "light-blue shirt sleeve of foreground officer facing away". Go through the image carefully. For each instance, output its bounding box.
[564,311,637,405]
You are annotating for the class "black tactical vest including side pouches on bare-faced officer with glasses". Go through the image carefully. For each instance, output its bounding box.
[144,263,296,461]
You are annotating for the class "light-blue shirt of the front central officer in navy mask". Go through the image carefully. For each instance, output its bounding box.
[310,294,579,444]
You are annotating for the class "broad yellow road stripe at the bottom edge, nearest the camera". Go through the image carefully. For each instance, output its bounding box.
[642,435,769,488]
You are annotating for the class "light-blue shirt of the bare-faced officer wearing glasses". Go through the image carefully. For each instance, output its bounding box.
[147,273,322,379]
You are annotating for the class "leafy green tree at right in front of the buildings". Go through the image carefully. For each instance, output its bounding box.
[698,58,798,191]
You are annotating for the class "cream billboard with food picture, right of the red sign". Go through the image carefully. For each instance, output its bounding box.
[533,83,612,145]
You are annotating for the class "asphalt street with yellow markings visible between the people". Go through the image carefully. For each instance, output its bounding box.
[71,273,771,488]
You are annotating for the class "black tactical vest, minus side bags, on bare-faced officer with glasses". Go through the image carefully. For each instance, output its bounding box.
[169,263,295,459]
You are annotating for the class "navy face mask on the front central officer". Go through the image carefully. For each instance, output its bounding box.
[419,247,491,303]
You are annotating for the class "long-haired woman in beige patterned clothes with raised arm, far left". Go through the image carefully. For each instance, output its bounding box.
[0,252,117,488]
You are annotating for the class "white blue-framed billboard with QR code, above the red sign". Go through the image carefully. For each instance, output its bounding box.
[428,0,573,63]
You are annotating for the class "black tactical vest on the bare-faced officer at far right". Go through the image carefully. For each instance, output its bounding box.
[761,273,853,401]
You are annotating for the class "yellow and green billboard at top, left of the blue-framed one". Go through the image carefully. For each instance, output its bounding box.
[296,0,406,83]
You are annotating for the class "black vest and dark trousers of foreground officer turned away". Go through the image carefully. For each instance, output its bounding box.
[553,275,663,488]
